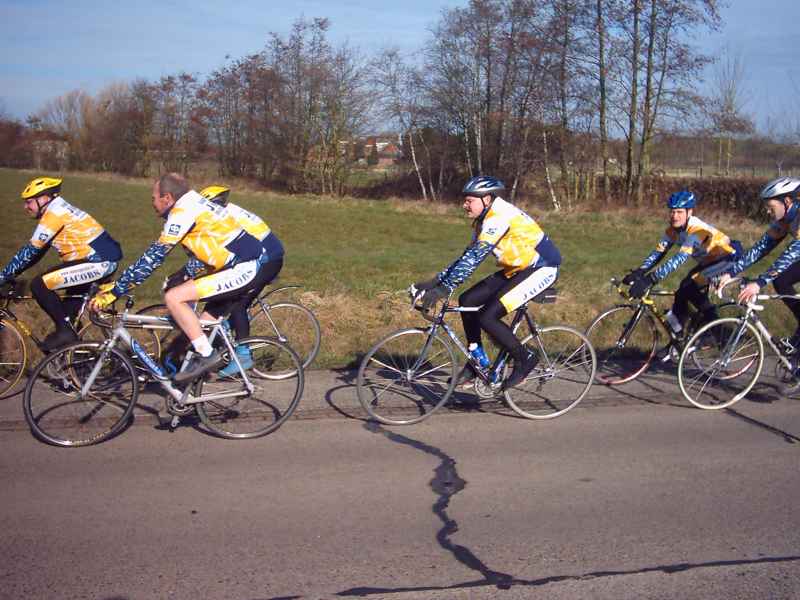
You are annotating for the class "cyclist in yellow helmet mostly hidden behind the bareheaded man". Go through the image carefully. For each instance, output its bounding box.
[200,185,284,377]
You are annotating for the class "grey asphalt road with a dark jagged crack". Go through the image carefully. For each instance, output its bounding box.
[0,372,800,600]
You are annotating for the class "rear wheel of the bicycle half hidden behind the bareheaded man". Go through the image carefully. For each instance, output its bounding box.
[249,300,322,369]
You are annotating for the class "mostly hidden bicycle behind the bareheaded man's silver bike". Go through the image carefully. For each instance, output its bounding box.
[138,285,322,369]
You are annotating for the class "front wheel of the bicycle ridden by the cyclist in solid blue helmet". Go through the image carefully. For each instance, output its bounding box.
[586,305,658,385]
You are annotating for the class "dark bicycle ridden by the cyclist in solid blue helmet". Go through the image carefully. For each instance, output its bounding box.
[586,277,741,385]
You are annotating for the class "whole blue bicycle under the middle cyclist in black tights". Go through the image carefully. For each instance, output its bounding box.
[356,286,596,425]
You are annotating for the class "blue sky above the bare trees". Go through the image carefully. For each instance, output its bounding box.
[0,0,800,123]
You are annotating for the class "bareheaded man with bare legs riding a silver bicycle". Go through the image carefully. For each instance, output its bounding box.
[92,173,265,384]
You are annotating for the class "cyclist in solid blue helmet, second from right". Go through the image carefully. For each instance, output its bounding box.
[622,190,741,342]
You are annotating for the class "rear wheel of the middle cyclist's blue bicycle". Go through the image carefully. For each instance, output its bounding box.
[503,325,597,419]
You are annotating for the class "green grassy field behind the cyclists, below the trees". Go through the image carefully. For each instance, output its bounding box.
[0,169,792,367]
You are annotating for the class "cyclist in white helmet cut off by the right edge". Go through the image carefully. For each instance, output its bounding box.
[720,177,800,354]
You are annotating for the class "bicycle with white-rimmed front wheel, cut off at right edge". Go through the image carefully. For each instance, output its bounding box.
[678,279,800,410]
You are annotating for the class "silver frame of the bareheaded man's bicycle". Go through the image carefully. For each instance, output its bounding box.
[81,310,255,406]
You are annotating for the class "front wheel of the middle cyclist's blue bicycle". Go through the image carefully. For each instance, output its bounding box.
[356,329,456,425]
